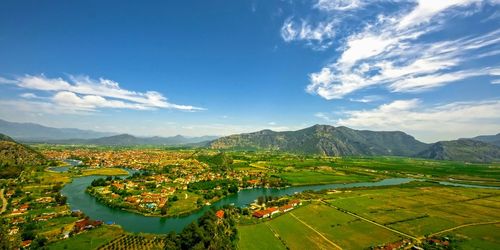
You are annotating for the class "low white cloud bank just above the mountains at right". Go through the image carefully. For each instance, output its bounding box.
[315,99,500,142]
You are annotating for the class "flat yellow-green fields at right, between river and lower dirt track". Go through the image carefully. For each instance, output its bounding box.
[328,186,500,237]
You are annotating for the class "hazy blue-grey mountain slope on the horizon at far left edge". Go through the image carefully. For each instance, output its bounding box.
[0,119,114,141]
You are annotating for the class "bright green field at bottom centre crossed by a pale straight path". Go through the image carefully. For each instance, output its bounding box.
[238,203,400,249]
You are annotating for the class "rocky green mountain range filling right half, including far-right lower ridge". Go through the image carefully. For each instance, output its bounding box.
[209,125,500,162]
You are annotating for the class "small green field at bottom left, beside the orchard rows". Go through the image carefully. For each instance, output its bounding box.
[48,226,123,250]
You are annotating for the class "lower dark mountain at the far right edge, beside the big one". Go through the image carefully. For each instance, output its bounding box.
[417,139,500,162]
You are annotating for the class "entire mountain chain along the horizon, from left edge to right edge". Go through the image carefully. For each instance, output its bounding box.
[0,120,500,162]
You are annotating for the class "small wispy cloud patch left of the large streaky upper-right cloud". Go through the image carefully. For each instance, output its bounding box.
[281,18,335,50]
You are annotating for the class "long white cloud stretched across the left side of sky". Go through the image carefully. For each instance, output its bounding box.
[6,75,202,113]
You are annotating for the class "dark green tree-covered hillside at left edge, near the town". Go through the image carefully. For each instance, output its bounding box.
[0,134,45,178]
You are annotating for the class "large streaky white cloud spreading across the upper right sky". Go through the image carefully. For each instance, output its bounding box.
[282,0,500,100]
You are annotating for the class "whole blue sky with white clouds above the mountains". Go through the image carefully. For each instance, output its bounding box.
[0,0,500,142]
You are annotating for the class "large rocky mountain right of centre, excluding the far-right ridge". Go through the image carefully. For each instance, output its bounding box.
[209,125,429,156]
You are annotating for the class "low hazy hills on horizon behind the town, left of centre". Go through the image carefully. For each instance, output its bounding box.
[46,134,218,146]
